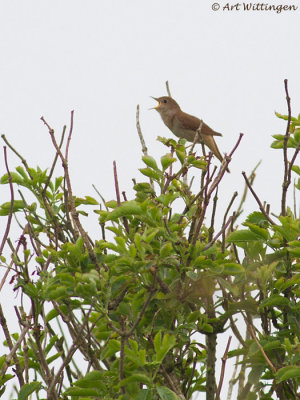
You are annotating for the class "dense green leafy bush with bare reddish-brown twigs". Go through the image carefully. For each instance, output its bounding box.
[0,86,300,400]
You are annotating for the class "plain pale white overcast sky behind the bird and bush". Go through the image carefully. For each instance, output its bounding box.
[0,0,300,396]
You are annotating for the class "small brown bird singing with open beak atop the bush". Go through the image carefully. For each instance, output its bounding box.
[151,96,229,172]
